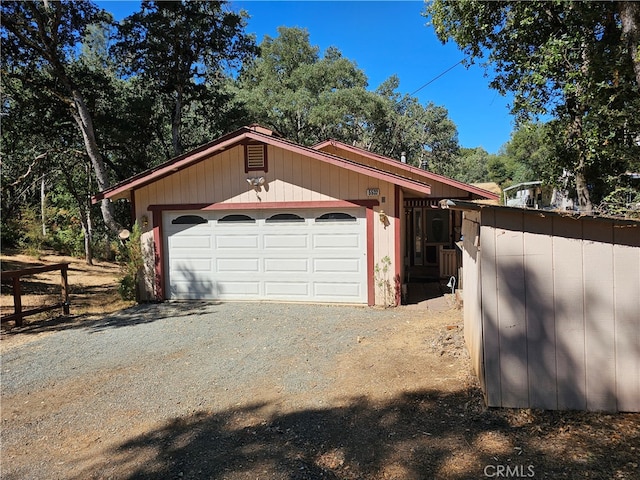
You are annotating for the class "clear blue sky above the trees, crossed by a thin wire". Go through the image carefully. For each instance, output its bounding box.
[96,0,513,153]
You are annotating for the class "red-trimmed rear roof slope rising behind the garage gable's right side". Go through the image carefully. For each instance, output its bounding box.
[312,140,500,200]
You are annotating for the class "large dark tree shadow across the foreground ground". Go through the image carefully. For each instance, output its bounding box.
[71,389,640,480]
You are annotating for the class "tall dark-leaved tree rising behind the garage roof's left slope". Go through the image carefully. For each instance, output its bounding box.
[113,0,256,156]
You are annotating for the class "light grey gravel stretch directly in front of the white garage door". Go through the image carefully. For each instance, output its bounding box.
[2,303,394,396]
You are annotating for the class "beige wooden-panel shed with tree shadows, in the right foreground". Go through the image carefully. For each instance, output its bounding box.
[446,201,640,412]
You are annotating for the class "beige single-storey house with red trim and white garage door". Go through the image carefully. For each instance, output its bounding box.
[93,125,497,305]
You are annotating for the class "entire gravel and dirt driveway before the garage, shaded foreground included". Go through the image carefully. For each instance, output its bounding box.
[2,303,640,480]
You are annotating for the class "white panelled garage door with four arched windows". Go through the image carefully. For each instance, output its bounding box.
[164,209,367,303]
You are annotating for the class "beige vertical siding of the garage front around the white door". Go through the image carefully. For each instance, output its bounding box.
[135,146,402,304]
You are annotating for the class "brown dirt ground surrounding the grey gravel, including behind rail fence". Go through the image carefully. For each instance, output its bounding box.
[0,255,640,480]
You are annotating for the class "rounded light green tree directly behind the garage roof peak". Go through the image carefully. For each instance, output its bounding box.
[237,27,375,145]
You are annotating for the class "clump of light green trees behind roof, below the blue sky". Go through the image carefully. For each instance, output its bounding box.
[238,27,458,169]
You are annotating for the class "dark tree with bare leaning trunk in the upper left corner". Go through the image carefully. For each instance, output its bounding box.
[2,0,121,232]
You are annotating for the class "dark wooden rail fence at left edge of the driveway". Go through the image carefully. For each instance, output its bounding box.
[0,263,69,327]
